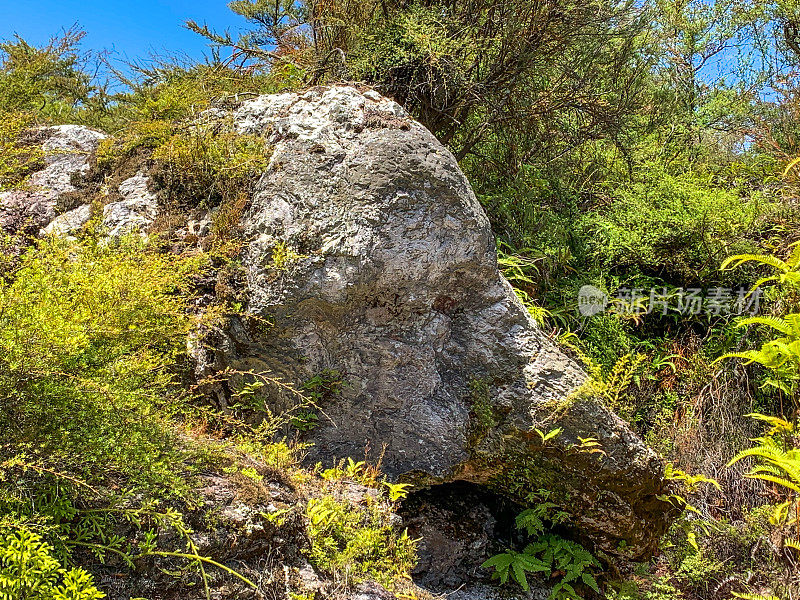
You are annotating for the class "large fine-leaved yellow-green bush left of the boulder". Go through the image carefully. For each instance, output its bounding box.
[0,238,206,486]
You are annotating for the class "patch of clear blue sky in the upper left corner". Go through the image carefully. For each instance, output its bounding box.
[0,0,244,69]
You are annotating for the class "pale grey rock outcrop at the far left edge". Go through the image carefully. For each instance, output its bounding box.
[0,125,106,235]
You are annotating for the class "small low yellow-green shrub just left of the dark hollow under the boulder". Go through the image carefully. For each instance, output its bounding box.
[307,496,415,585]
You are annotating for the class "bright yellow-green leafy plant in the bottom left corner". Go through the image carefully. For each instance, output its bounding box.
[0,527,106,600]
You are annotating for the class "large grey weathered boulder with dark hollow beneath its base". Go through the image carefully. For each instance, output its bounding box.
[195,87,671,557]
